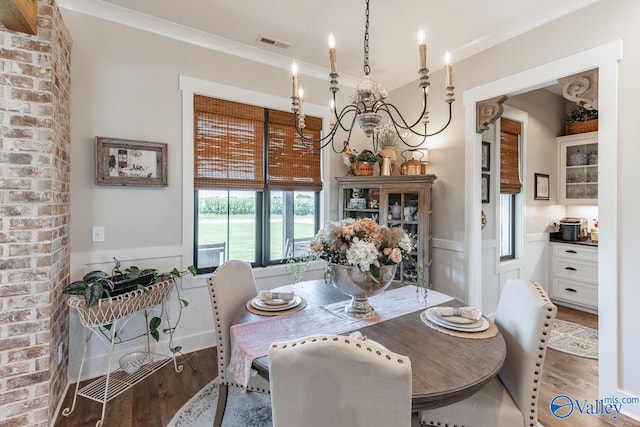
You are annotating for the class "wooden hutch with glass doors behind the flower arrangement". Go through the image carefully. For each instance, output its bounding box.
[336,175,436,287]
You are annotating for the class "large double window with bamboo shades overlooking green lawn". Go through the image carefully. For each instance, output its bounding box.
[194,95,322,273]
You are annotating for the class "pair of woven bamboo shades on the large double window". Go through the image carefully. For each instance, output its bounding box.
[194,95,322,191]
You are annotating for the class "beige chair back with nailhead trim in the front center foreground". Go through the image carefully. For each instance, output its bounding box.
[268,335,411,427]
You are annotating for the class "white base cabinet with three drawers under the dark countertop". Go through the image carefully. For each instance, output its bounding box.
[550,242,598,312]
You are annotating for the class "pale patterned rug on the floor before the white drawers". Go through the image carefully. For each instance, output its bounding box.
[549,319,598,359]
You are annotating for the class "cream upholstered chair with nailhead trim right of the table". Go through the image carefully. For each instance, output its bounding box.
[420,280,557,427]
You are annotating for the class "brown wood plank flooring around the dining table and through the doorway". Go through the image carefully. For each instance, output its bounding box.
[54,307,640,427]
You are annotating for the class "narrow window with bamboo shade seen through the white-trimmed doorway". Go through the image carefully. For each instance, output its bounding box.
[500,118,522,261]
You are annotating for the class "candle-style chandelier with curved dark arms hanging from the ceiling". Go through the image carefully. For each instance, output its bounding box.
[291,0,455,153]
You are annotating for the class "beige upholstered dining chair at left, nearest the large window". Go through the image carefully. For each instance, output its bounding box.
[208,260,269,427]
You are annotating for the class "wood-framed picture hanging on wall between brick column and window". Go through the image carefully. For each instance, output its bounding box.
[95,136,167,187]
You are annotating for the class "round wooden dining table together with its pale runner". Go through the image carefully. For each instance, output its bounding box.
[231,280,506,412]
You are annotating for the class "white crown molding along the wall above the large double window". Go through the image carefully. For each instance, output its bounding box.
[58,0,360,88]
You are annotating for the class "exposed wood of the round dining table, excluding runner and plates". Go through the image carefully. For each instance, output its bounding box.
[234,280,507,411]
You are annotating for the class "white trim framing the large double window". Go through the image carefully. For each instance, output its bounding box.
[179,75,335,288]
